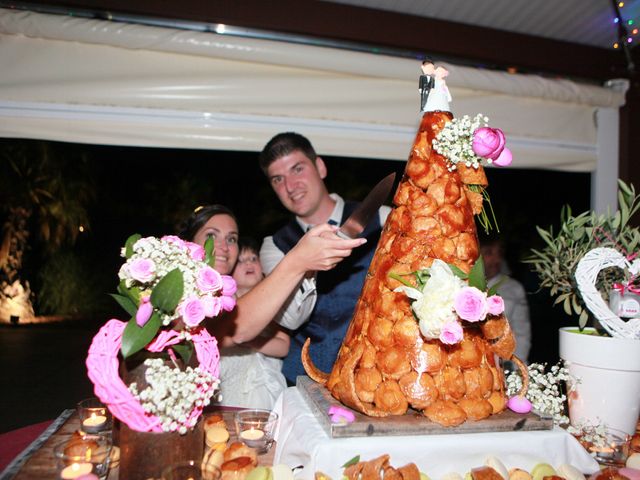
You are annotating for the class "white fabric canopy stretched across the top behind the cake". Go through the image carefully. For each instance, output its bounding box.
[0,9,624,171]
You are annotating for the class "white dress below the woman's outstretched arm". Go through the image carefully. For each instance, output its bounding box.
[216,347,287,410]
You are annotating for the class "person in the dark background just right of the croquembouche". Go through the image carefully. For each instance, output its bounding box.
[480,236,531,363]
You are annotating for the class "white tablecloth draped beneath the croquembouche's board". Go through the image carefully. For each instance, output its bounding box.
[274,387,598,480]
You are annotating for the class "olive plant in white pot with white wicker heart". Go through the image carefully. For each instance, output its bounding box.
[526,181,640,434]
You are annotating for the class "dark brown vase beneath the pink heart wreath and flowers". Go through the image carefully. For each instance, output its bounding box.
[118,352,204,480]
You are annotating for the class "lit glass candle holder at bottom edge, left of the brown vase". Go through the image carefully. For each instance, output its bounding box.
[53,435,112,480]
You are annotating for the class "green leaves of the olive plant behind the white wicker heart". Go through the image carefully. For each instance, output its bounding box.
[524,180,640,328]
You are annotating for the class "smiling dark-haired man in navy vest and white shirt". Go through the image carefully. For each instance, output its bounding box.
[259,132,390,385]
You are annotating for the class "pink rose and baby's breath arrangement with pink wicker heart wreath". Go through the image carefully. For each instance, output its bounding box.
[87,235,236,433]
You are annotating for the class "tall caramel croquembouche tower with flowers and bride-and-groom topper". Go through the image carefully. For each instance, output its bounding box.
[303,62,526,426]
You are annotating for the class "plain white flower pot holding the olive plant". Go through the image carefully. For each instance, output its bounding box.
[560,327,640,435]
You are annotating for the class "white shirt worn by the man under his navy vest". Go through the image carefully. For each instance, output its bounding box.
[260,193,391,330]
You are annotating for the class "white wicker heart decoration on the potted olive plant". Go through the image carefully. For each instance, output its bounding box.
[575,248,640,339]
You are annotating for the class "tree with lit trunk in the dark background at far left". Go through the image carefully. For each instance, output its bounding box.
[0,140,93,316]
